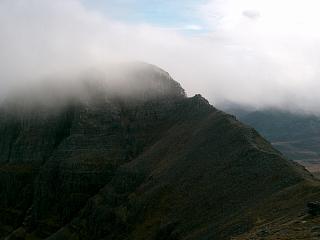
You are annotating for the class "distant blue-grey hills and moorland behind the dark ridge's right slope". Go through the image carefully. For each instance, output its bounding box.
[224,108,320,176]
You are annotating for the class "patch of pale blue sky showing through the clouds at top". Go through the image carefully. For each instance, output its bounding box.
[81,0,207,31]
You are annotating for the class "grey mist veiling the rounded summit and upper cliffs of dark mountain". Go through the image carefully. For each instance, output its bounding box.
[1,62,185,112]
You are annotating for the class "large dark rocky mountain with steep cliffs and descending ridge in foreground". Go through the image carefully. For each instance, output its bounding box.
[0,65,320,240]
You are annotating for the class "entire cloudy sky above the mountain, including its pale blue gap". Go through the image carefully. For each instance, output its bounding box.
[0,0,320,113]
